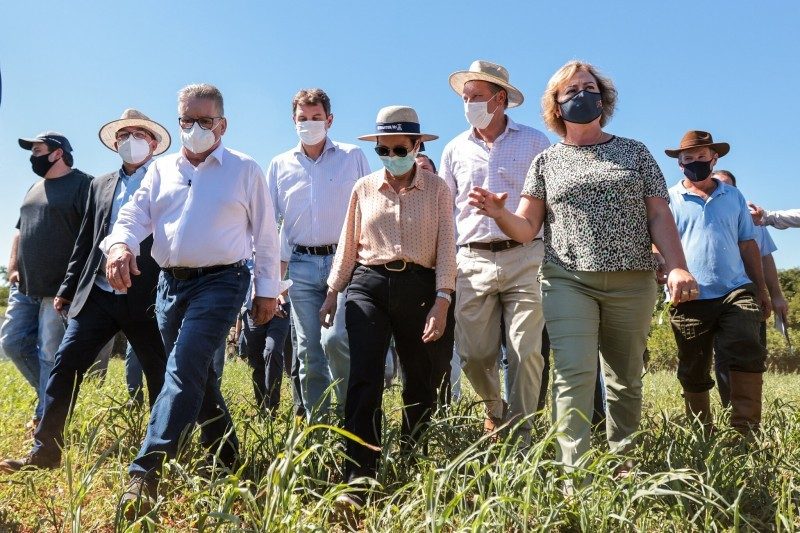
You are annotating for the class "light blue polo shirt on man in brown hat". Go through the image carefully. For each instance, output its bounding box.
[669,179,756,300]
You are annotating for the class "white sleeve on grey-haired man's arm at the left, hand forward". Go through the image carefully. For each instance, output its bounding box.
[100,165,159,255]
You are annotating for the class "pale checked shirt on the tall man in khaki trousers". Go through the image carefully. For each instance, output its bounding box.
[439,117,550,246]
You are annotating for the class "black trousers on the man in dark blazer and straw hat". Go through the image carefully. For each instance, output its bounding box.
[34,286,167,458]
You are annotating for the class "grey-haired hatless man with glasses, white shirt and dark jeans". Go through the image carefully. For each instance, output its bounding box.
[101,84,280,519]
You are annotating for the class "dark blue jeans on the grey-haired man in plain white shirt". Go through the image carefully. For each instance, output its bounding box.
[128,266,250,476]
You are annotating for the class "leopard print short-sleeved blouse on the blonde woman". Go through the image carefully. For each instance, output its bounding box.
[522,137,669,272]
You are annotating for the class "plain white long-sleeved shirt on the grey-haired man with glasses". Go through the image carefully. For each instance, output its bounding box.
[100,143,280,297]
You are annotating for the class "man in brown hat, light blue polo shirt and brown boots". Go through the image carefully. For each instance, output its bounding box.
[665,131,771,432]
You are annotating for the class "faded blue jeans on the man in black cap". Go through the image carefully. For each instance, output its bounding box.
[0,285,65,418]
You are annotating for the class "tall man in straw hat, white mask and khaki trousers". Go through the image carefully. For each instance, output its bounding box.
[439,60,550,440]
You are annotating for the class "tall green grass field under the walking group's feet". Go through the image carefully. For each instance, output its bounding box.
[0,360,800,533]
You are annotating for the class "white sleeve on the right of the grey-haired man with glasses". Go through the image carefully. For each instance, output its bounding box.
[248,163,281,298]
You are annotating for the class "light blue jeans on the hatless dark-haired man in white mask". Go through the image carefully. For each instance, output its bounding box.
[287,252,350,420]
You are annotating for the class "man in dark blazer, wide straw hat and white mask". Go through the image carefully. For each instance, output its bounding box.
[0,109,170,472]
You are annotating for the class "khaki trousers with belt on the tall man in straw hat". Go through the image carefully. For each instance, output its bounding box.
[455,240,544,425]
